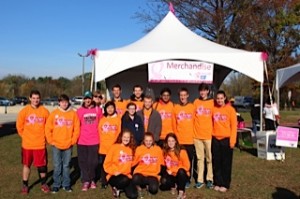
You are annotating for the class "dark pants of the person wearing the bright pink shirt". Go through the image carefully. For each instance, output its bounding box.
[77,144,99,182]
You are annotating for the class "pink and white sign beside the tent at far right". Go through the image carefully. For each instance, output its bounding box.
[276,126,299,148]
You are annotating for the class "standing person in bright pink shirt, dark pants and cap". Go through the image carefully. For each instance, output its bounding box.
[77,91,102,191]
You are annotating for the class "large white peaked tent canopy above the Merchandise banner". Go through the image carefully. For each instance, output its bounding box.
[95,12,263,82]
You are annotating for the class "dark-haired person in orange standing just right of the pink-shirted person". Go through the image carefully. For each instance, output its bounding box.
[98,101,121,189]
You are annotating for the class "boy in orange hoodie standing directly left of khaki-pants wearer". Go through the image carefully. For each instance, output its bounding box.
[173,88,195,188]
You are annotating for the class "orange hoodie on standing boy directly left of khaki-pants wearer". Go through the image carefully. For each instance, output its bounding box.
[173,103,195,144]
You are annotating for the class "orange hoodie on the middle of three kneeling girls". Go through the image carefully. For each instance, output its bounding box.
[133,145,164,179]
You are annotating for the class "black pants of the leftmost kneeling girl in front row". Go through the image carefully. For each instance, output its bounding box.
[108,174,138,198]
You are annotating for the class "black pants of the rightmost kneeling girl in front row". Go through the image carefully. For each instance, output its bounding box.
[160,169,189,191]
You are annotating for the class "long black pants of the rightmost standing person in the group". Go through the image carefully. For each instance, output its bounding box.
[212,137,233,189]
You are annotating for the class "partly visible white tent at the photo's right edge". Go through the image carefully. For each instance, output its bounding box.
[275,63,300,106]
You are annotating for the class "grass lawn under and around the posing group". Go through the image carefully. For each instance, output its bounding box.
[0,134,300,199]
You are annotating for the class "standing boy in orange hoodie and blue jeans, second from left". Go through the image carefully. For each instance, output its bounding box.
[46,94,80,193]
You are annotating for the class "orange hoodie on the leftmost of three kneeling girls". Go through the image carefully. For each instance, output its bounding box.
[103,144,133,180]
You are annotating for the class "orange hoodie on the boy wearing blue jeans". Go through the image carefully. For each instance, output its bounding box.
[46,108,80,150]
